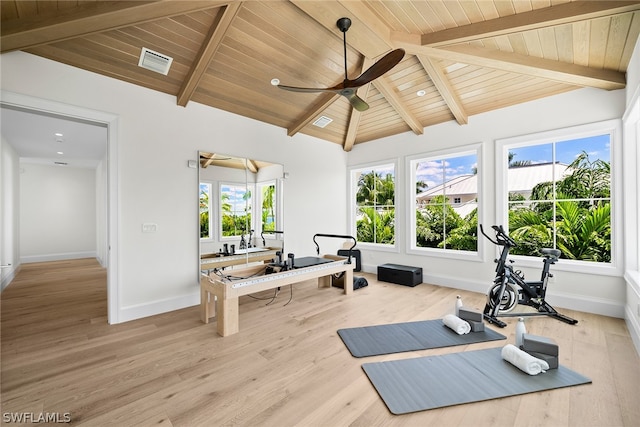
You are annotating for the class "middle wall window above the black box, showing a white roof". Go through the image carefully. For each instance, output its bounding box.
[408,147,479,253]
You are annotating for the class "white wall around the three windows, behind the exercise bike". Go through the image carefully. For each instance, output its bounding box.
[348,89,626,317]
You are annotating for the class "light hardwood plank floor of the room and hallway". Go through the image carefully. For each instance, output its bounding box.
[1,259,640,427]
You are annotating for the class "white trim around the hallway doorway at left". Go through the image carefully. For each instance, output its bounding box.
[0,90,120,324]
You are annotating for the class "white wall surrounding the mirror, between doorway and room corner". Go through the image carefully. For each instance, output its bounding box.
[1,52,347,322]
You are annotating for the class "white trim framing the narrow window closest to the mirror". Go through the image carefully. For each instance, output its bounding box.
[347,159,403,253]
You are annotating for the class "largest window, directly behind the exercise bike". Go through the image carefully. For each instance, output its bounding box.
[499,122,615,270]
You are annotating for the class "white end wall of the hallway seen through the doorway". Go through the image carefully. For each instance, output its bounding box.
[20,162,97,263]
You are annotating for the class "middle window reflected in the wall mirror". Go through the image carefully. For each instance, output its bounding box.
[220,184,251,238]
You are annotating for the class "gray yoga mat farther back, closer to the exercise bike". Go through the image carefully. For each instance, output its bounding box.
[338,319,506,357]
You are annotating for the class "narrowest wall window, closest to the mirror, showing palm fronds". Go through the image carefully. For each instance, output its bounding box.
[351,163,396,246]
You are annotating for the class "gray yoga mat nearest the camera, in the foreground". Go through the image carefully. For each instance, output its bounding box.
[362,347,591,415]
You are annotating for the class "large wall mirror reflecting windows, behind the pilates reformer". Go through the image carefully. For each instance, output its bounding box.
[198,151,284,274]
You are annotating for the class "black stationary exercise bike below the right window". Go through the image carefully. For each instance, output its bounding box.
[480,224,578,328]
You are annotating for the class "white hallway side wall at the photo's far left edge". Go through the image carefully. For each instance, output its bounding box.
[0,138,20,290]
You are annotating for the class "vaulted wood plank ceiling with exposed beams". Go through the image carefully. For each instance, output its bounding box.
[0,0,640,151]
